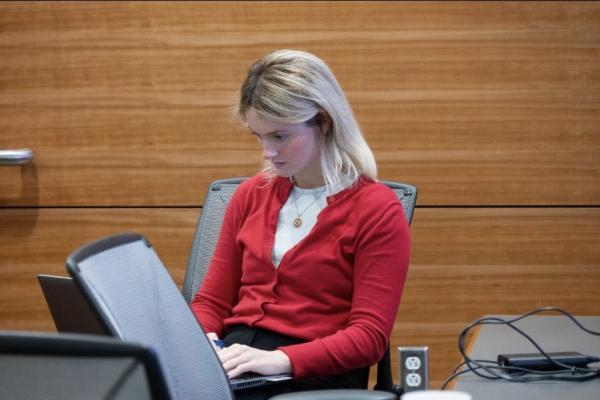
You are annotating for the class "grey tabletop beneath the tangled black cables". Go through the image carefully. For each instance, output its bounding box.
[454,315,600,400]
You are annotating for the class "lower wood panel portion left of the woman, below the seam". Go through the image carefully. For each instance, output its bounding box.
[0,208,200,330]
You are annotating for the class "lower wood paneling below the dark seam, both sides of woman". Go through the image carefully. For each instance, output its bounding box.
[0,208,600,384]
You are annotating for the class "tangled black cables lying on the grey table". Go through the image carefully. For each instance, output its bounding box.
[442,307,600,390]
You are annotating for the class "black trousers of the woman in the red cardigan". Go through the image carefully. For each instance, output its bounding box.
[223,325,364,400]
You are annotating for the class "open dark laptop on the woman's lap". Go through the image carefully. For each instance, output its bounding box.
[38,274,292,391]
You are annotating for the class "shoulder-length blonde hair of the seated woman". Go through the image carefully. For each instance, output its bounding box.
[236,50,377,193]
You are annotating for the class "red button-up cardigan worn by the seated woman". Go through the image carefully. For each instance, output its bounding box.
[191,175,410,377]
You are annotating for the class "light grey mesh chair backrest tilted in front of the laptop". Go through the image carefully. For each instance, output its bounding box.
[67,234,233,400]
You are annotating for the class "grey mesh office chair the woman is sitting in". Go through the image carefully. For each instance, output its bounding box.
[183,178,417,392]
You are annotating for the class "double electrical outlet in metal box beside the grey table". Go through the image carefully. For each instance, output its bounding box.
[398,347,429,392]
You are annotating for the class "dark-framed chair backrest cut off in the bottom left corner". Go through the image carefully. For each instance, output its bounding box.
[0,331,171,400]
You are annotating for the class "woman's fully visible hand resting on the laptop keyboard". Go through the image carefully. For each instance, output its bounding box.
[218,344,292,378]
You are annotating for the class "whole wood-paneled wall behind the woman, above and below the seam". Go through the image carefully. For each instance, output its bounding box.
[0,2,600,387]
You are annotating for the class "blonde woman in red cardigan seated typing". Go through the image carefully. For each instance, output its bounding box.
[192,50,410,395]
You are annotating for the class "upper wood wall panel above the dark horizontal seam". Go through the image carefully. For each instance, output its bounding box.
[0,2,600,206]
